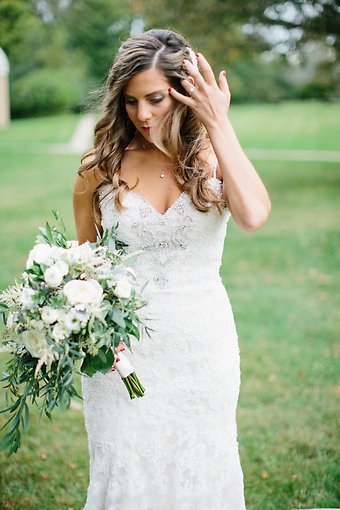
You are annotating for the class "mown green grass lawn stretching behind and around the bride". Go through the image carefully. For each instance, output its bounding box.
[0,104,340,510]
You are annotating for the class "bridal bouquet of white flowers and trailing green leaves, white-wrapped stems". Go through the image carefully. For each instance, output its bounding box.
[0,212,149,455]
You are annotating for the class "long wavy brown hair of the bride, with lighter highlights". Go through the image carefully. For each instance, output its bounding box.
[78,29,223,223]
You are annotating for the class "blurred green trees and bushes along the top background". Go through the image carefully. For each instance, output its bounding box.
[0,0,340,116]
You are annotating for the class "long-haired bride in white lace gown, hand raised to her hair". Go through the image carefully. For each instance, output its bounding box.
[73,29,271,510]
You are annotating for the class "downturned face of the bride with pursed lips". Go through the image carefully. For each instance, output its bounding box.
[123,68,174,141]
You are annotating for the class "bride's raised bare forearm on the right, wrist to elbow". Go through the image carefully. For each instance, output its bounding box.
[208,117,271,231]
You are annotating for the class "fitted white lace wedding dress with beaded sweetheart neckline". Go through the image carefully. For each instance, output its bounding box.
[82,161,245,510]
